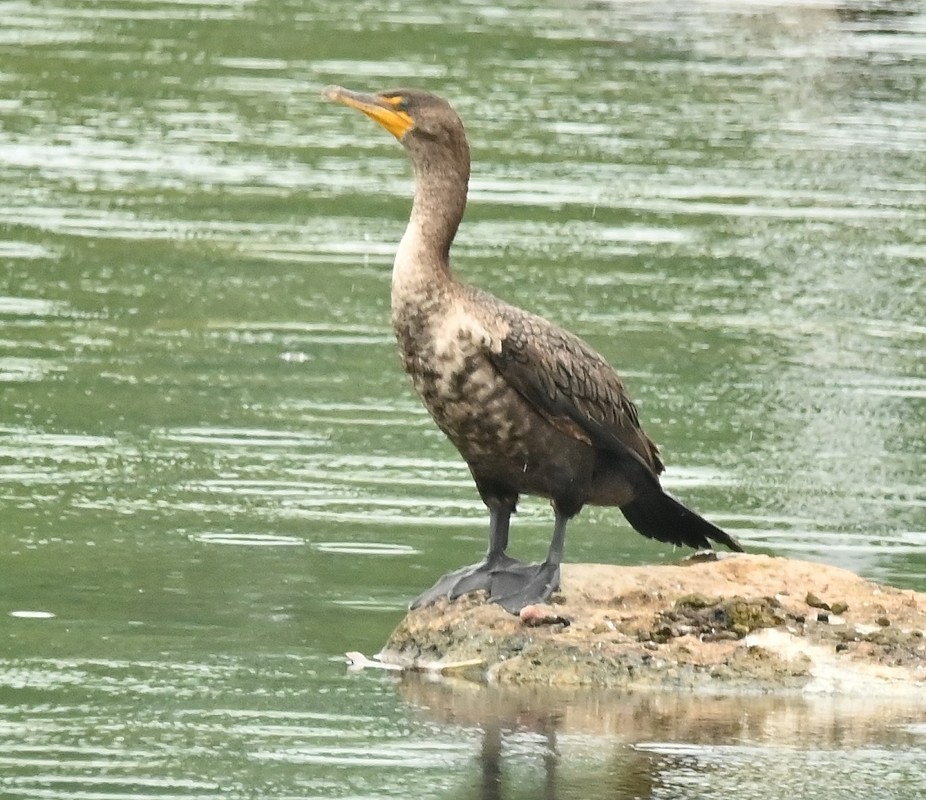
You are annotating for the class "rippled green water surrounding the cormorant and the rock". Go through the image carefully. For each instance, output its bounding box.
[0,0,926,800]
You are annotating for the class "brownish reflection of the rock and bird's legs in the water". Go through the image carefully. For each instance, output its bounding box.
[400,675,926,800]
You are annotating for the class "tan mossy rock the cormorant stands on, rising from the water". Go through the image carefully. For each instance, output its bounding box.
[381,555,926,697]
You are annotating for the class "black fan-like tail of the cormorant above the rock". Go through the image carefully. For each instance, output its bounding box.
[621,487,743,553]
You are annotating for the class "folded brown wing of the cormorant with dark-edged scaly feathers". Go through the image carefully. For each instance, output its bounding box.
[478,298,663,475]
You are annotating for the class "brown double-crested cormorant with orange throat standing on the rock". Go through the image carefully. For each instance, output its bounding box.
[324,86,742,613]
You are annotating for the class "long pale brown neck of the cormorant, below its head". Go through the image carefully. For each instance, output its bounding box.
[392,141,469,300]
